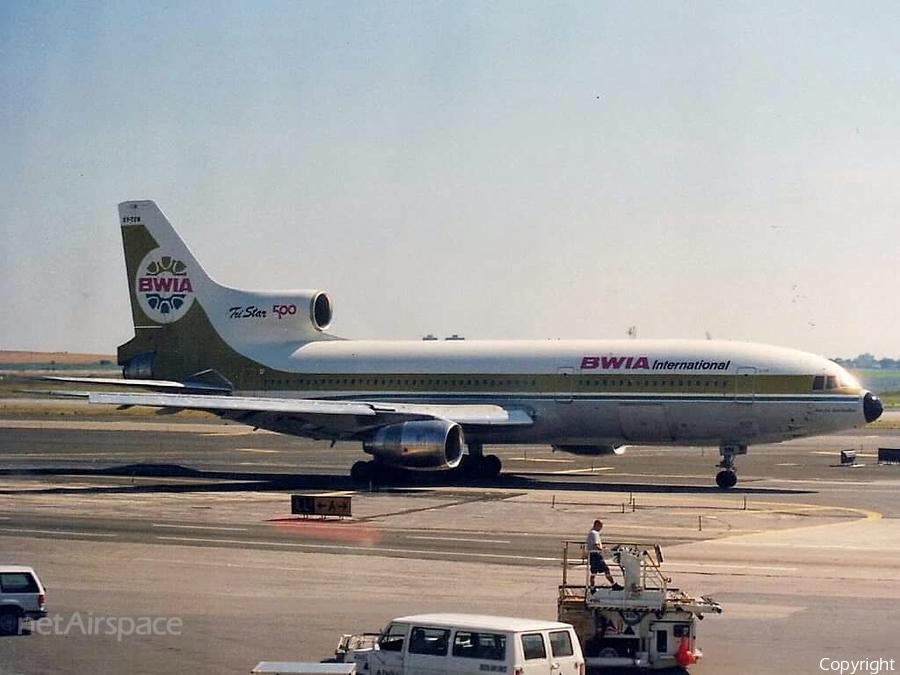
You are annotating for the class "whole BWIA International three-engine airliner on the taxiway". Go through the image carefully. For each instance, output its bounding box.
[56,200,883,489]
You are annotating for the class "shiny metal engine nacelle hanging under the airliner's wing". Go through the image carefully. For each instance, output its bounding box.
[363,420,465,471]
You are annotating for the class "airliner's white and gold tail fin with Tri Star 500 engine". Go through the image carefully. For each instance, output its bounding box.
[118,200,333,383]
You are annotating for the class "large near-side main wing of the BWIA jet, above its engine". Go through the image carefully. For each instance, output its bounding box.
[88,393,534,438]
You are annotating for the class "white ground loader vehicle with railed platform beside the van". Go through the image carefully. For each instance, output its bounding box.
[557,541,722,672]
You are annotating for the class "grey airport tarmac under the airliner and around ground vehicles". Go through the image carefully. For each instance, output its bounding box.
[0,412,900,675]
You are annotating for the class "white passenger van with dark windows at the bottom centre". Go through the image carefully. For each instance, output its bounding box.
[345,614,584,675]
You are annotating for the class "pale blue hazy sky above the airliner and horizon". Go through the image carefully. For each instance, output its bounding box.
[0,0,900,357]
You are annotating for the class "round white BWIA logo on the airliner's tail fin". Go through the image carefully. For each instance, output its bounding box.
[134,249,194,323]
